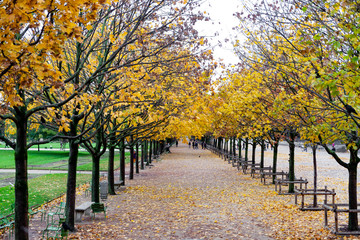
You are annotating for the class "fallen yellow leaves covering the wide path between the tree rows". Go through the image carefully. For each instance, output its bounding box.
[67,148,358,240]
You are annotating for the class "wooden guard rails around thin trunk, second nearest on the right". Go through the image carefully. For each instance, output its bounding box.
[294,186,336,211]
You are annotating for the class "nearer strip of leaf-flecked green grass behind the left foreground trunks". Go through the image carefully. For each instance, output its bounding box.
[0,173,91,216]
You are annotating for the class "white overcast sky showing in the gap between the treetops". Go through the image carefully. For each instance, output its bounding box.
[195,0,241,64]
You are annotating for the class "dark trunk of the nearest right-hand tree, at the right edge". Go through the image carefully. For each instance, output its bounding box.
[348,148,359,231]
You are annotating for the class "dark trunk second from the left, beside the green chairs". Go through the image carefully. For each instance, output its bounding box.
[65,140,79,230]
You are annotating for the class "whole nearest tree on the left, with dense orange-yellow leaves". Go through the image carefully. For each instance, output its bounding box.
[0,1,104,239]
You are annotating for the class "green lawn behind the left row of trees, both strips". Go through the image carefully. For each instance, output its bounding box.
[0,147,135,217]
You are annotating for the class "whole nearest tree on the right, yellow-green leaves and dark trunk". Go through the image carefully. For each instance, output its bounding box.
[238,1,359,230]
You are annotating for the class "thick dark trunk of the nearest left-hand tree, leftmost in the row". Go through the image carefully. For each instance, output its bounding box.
[15,107,29,240]
